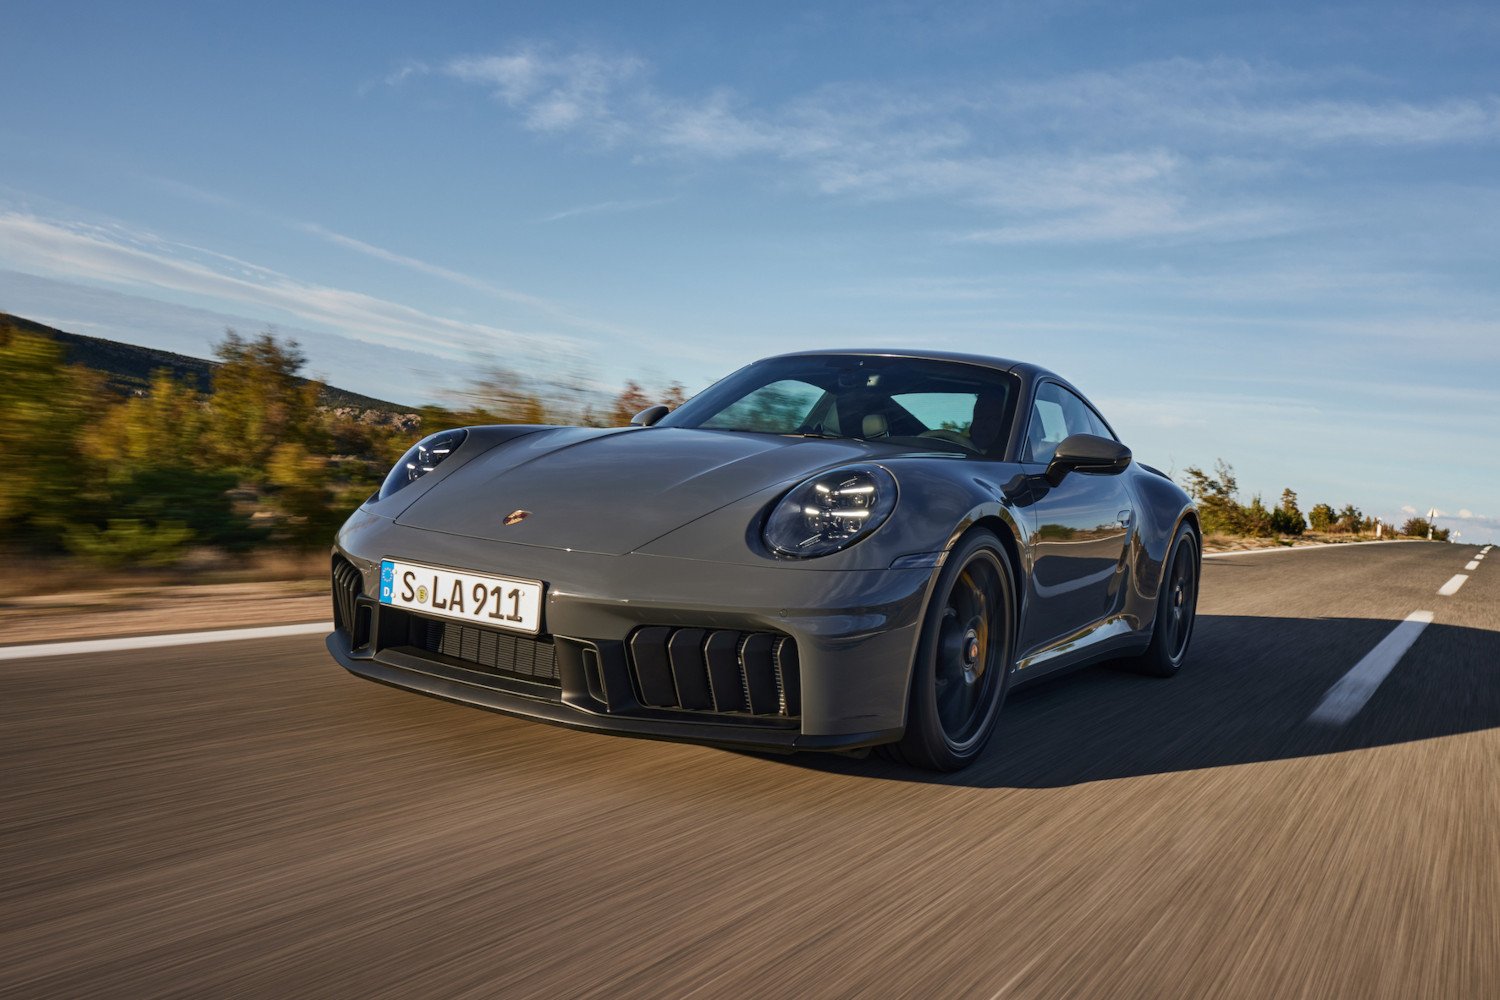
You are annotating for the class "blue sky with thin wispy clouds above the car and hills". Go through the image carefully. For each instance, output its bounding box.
[0,0,1500,541]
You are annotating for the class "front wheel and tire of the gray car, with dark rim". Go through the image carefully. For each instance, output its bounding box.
[884,531,1016,771]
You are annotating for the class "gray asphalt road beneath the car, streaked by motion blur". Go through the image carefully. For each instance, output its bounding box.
[0,544,1500,1000]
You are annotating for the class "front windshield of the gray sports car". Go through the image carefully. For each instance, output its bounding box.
[659,354,1016,457]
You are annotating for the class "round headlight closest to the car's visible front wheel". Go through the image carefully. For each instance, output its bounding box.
[765,465,896,559]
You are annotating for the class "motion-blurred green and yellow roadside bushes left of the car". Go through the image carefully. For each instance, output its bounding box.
[0,319,683,574]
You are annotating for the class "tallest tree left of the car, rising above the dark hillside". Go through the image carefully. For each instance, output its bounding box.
[210,328,323,470]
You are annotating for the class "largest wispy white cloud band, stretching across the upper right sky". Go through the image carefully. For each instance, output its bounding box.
[405,45,1500,243]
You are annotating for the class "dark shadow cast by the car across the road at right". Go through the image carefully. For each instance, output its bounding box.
[762,615,1500,789]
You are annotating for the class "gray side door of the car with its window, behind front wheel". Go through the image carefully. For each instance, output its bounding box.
[1020,381,1134,657]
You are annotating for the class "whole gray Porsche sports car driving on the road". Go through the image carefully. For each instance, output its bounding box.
[329,351,1200,769]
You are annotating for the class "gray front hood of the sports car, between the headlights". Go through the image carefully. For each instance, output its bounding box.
[396,427,896,555]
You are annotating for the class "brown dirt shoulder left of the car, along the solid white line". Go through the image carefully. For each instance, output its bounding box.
[0,577,333,646]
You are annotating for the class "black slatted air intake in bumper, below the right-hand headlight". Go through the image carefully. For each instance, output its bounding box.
[627,625,803,718]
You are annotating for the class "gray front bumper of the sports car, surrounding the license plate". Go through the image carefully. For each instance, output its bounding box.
[327,513,932,751]
